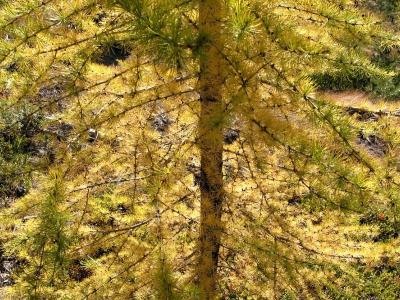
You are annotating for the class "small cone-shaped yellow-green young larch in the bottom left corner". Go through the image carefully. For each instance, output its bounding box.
[8,171,72,299]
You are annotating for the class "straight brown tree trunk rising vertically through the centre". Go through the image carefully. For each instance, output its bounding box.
[198,0,224,299]
